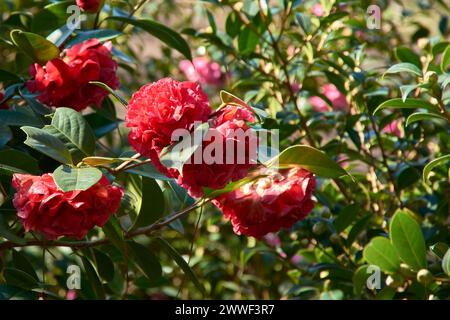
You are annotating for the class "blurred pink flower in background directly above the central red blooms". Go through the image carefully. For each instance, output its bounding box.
[179,57,224,85]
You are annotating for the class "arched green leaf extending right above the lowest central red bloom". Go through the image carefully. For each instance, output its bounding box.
[267,145,349,178]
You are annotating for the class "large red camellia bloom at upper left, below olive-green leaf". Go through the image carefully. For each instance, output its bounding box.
[27,39,119,111]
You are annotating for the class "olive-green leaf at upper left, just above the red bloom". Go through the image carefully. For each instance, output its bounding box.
[11,30,60,64]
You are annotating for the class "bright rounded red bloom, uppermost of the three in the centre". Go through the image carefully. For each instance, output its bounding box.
[125,78,212,177]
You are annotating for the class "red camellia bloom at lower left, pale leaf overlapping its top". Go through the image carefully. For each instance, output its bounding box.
[12,174,123,239]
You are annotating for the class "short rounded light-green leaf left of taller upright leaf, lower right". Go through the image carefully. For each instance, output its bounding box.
[363,237,401,273]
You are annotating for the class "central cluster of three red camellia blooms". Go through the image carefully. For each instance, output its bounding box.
[126,78,315,238]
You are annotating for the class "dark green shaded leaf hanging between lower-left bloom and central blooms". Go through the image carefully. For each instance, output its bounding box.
[132,177,165,230]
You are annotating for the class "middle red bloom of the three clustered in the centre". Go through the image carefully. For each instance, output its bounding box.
[177,105,258,197]
